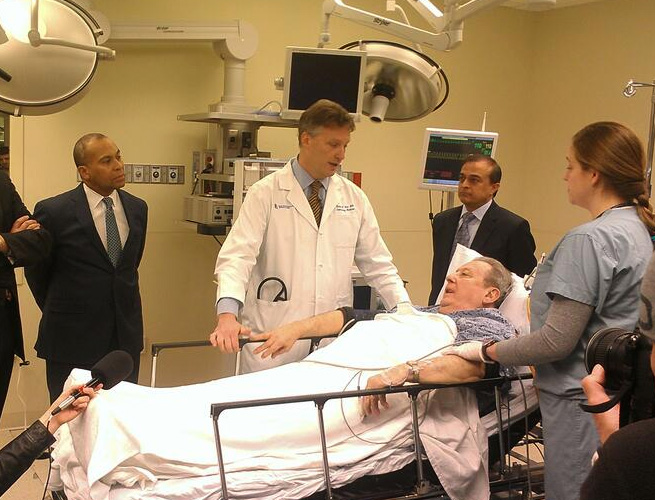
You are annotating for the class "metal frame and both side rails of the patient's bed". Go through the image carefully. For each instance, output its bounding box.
[137,337,543,500]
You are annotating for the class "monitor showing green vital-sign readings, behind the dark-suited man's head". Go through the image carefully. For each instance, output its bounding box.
[418,128,498,191]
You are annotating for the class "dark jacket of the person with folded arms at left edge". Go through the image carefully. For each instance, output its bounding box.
[0,172,50,360]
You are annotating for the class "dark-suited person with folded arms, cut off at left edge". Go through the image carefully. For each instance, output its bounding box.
[0,172,50,414]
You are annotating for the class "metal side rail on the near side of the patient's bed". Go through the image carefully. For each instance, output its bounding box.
[210,377,507,500]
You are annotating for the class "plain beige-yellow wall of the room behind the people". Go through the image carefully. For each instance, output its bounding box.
[0,0,655,427]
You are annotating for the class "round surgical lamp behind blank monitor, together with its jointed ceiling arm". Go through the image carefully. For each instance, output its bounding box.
[319,0,524,122]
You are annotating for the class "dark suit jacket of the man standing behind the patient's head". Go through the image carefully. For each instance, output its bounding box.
[429,201,537,305]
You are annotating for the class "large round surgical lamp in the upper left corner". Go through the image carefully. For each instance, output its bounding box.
[0,0,114,116]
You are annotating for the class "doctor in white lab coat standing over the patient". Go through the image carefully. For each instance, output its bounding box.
[209,100,409,373]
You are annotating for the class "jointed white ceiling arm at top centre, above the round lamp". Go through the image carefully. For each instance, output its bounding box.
[319,0,505,50]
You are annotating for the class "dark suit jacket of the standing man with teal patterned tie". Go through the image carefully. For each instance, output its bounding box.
[25,184,148,364]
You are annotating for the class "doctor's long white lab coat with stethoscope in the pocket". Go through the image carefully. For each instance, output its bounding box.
[215,162,409,373]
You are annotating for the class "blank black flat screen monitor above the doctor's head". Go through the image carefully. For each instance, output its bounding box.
[280,47,366,119]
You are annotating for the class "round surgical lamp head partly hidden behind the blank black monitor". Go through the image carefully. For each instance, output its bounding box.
[341,40,448,122]
